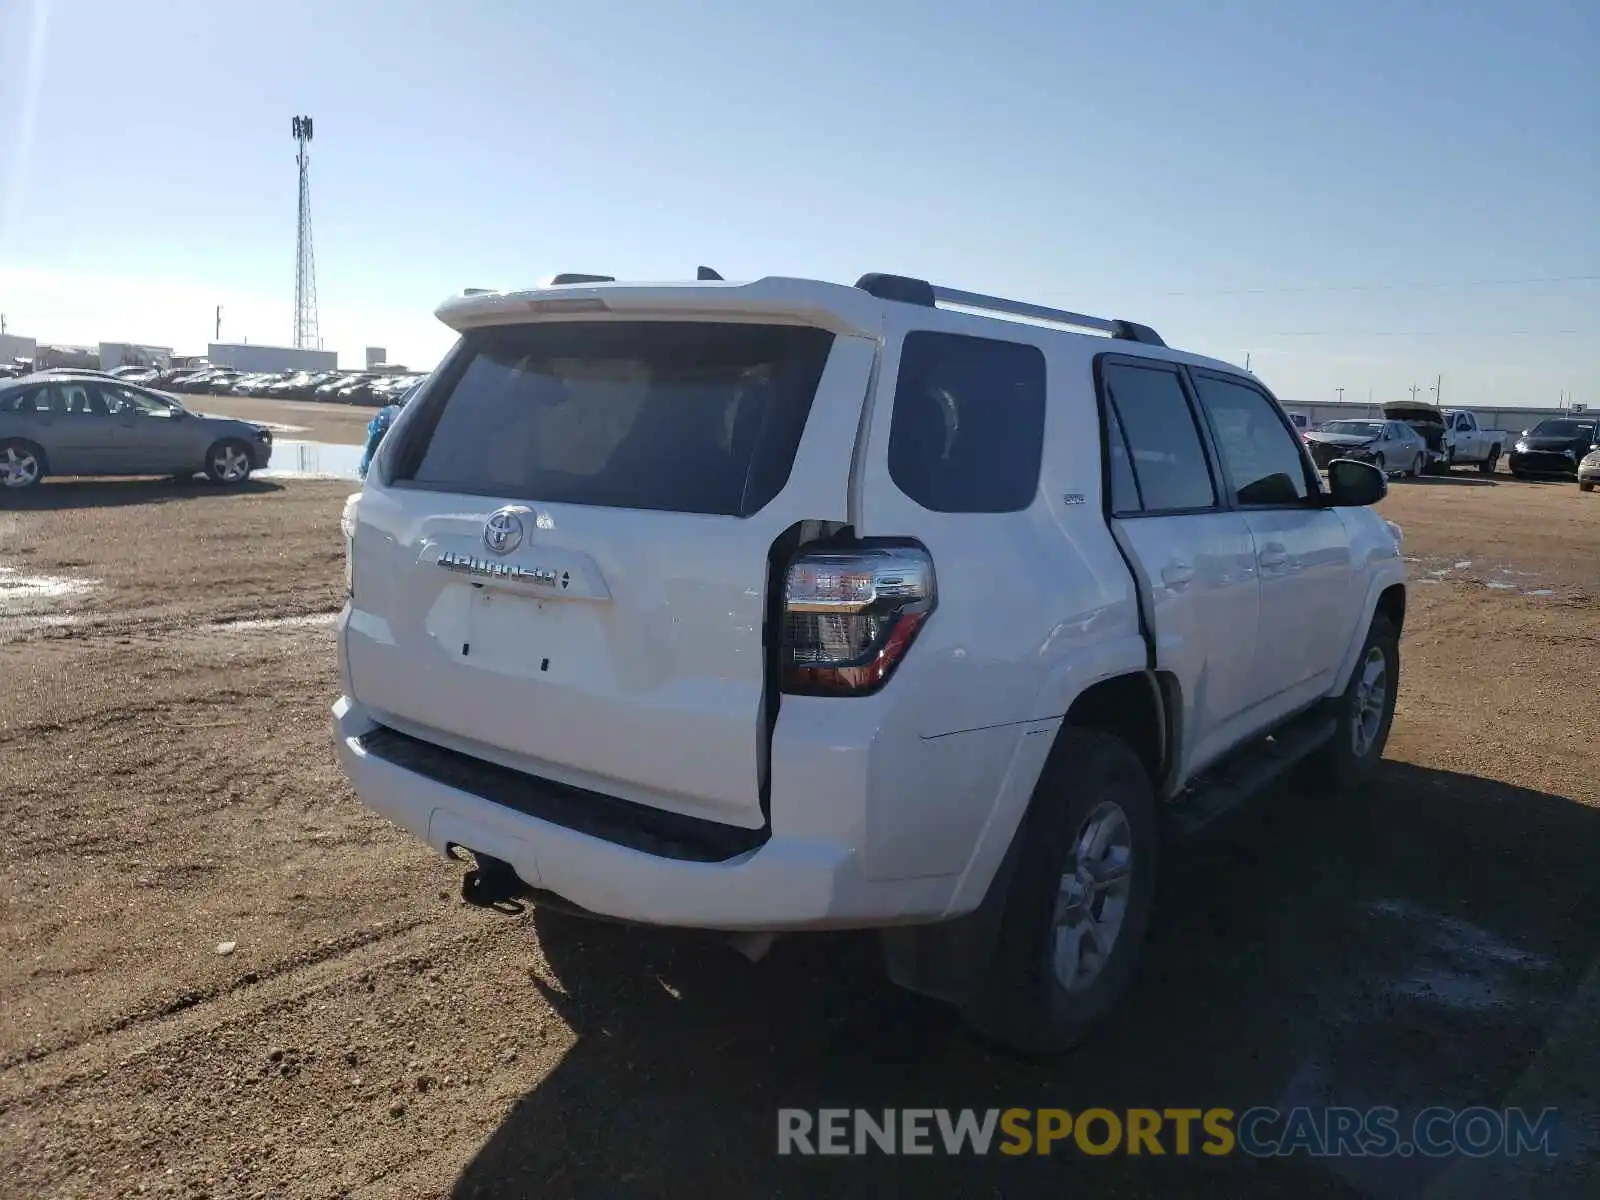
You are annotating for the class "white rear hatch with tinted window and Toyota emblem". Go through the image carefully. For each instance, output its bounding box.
[346,309,874,829]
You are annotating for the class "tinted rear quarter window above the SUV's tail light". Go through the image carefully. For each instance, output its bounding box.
[890,331,1045,512]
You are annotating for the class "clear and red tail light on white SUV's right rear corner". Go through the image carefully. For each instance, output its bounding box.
[781,546,938,696]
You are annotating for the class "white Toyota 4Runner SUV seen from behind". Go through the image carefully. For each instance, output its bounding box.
[333,270,1405,1050]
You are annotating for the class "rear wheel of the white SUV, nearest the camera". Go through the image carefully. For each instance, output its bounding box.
[962,726,1160,1053]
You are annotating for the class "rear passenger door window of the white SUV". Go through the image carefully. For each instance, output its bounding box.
[1101,363,1216,512]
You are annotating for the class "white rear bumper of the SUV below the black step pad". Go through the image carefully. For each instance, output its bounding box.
[333,696,955,931]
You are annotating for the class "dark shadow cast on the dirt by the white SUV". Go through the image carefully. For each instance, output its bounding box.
[454,762,1600,1200]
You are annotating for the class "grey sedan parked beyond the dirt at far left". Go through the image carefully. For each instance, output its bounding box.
[0,373,272,490]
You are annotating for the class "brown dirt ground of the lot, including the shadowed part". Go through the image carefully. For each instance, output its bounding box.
[0,473,1600,1200]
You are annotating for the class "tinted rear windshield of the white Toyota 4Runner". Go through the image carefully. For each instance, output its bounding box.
[394,322,834,517]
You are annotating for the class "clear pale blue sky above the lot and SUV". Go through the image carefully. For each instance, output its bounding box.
[0,0,1600,405]
